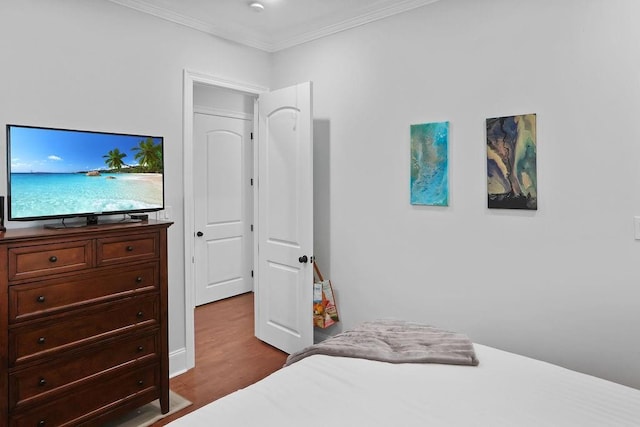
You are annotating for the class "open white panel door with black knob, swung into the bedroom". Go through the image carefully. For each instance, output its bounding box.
[256,83,313,353]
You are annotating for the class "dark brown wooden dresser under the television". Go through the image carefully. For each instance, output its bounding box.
[0,220,171,427]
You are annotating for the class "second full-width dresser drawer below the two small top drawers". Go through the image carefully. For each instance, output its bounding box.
[9,295,160,366]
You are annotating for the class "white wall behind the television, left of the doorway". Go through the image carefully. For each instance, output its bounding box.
[0,0,269,372]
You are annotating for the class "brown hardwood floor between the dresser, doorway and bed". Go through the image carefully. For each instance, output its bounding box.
[153,292,287,427]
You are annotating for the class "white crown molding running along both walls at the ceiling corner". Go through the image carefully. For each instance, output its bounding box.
[109,0,439,53]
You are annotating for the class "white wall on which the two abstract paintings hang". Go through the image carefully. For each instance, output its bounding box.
[270,0,640,388]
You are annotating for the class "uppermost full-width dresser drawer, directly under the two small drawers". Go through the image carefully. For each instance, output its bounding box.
[9,262,160,323]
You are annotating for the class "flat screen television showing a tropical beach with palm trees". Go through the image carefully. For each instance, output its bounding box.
[7,124,164,227]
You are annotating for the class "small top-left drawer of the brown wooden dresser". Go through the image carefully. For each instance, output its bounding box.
[8,240,93,281]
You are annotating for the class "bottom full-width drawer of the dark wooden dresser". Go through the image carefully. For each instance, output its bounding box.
[9,365,159,427]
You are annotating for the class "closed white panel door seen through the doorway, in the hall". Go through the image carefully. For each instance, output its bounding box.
[193,113,253,305]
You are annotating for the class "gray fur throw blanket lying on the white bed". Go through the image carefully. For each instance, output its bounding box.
[284,319,479,366]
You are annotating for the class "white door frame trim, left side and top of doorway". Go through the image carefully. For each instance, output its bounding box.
[182,69,269,371]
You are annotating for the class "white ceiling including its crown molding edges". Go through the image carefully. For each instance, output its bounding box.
[109,0,438,52]
